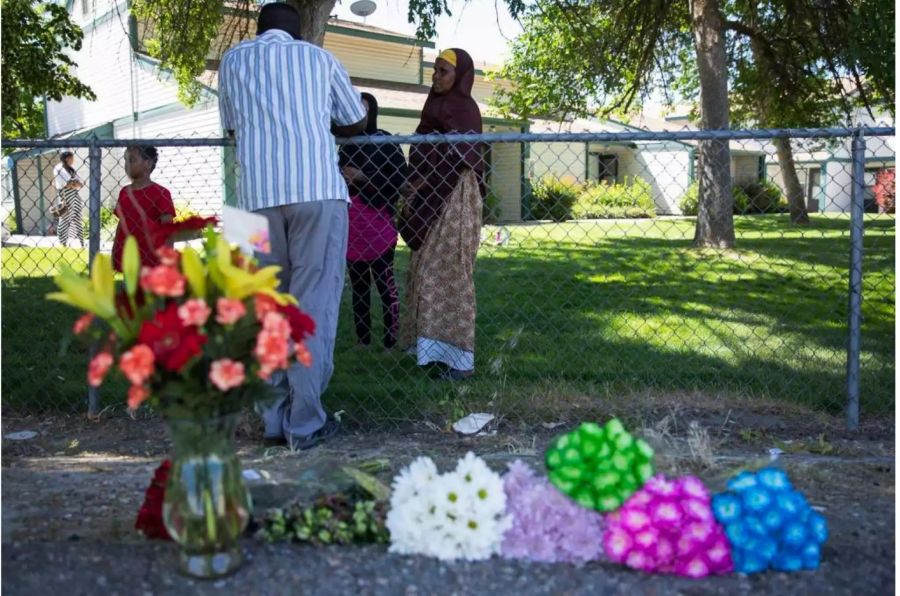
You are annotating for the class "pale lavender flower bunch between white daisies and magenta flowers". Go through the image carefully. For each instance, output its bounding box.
[501,460,603,563]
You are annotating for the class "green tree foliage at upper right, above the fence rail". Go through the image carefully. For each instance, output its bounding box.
[494,0,894,126]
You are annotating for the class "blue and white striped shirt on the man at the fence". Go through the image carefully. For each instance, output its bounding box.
[219,29,366,211]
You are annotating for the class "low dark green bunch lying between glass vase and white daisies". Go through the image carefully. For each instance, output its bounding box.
[257,494,388,546]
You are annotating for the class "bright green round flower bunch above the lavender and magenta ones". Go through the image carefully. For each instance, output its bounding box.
[546,418,653,512]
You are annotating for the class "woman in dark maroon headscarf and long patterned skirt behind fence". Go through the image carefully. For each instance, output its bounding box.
[398,49,484,380]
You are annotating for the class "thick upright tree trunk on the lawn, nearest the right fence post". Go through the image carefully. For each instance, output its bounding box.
[689,0,734,248]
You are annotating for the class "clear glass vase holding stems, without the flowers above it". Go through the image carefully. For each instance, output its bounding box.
[163,415,252,578]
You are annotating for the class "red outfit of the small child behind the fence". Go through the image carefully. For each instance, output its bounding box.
[113,182,175,271]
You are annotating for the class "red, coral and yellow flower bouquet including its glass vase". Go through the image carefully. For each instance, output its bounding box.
[47,222,315,577]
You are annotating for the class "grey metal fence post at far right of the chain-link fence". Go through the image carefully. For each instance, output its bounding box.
[847,129,866,430]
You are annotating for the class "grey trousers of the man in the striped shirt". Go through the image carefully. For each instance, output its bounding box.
[257,201,348,439]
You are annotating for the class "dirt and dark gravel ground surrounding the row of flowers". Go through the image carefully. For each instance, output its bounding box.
[2,419,895,596]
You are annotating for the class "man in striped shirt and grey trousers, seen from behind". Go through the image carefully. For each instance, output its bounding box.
[219,3,366,449]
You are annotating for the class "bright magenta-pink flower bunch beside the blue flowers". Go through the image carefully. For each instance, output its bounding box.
[603,475,733,578]
